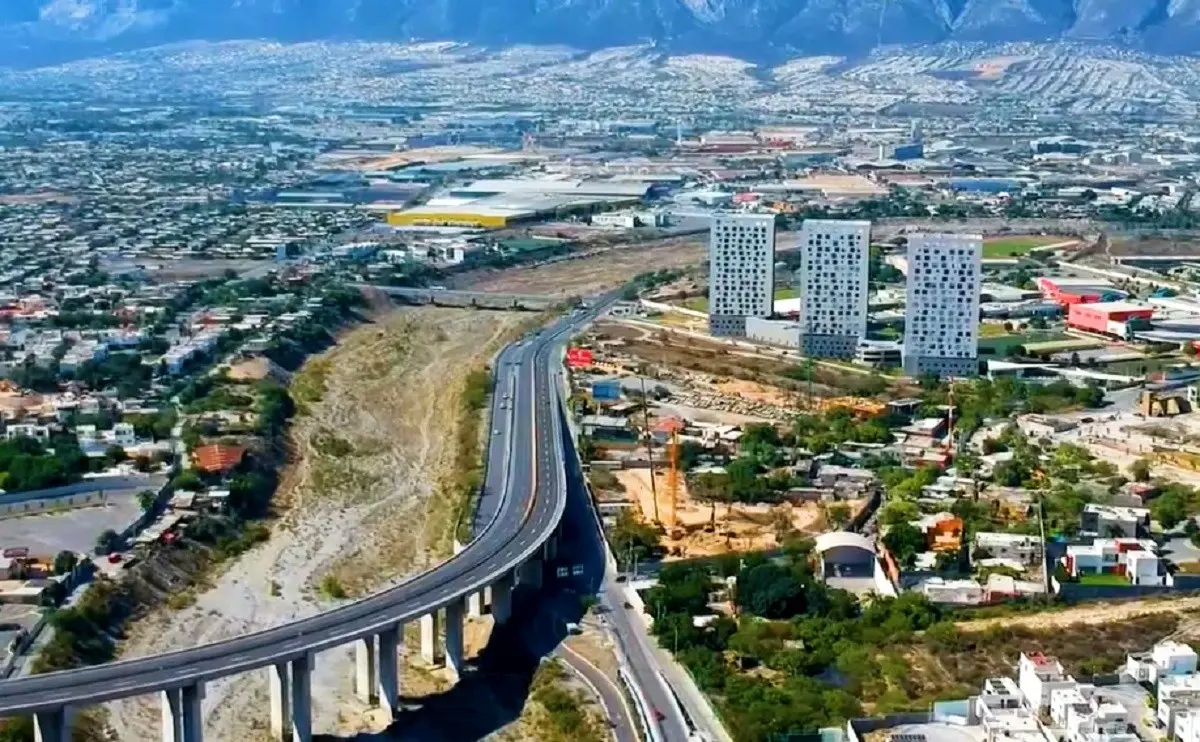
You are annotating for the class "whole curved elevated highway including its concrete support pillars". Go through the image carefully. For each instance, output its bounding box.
[0,303,607,742]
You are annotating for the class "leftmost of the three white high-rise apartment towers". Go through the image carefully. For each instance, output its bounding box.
[708,214,775,337]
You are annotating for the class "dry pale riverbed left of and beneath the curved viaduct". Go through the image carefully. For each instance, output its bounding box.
[109,307,529,742]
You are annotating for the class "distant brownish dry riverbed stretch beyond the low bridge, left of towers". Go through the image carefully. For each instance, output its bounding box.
[455,237,707,297]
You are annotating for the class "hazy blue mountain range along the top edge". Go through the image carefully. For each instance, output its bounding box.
[7,0,1200,64]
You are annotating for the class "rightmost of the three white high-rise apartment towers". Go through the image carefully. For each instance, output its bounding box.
[904,234,983,376]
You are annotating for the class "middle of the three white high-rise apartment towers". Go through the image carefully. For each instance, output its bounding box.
[799,219,871,358]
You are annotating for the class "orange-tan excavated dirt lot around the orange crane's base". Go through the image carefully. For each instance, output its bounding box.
[614,469,863,558]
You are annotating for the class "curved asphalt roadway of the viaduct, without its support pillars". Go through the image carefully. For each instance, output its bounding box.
[0,307,599,717]
